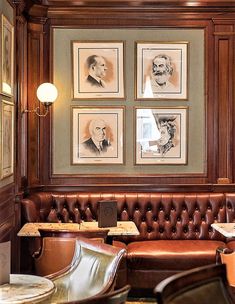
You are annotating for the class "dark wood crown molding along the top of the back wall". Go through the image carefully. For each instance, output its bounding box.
[21,0,235,24]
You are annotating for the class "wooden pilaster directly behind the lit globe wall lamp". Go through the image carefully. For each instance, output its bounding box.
[27,18,50,185]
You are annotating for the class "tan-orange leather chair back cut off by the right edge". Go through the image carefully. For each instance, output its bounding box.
[217,248,235,287]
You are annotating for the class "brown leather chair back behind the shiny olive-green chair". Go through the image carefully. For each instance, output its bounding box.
[33,229,109,276]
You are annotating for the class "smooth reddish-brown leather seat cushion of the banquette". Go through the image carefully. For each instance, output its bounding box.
[127,240,225,271]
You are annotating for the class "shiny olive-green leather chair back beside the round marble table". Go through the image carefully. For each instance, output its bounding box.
[47,238,126,302]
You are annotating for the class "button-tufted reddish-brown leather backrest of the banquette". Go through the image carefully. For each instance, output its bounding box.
[22,192,235,240]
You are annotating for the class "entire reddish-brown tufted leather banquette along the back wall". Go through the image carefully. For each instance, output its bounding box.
[22,192,235,294]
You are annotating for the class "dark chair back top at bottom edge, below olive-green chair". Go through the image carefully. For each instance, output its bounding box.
[58,285,131,304]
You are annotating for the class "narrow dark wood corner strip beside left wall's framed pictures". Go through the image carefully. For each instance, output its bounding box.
[12,0,27,273]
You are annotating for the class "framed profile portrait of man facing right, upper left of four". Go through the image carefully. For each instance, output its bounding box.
[72,41,124,99]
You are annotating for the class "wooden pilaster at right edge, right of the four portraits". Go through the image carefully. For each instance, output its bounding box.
[214,20,235,184]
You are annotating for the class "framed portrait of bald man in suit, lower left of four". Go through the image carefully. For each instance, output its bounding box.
[71,106,124,164]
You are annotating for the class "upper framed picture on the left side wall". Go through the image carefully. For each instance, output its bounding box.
[1,15,14,96]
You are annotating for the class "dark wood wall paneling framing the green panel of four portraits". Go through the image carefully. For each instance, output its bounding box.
[14,0,235,191]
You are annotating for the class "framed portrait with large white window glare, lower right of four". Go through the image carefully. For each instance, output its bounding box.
[135,107,188,165]
